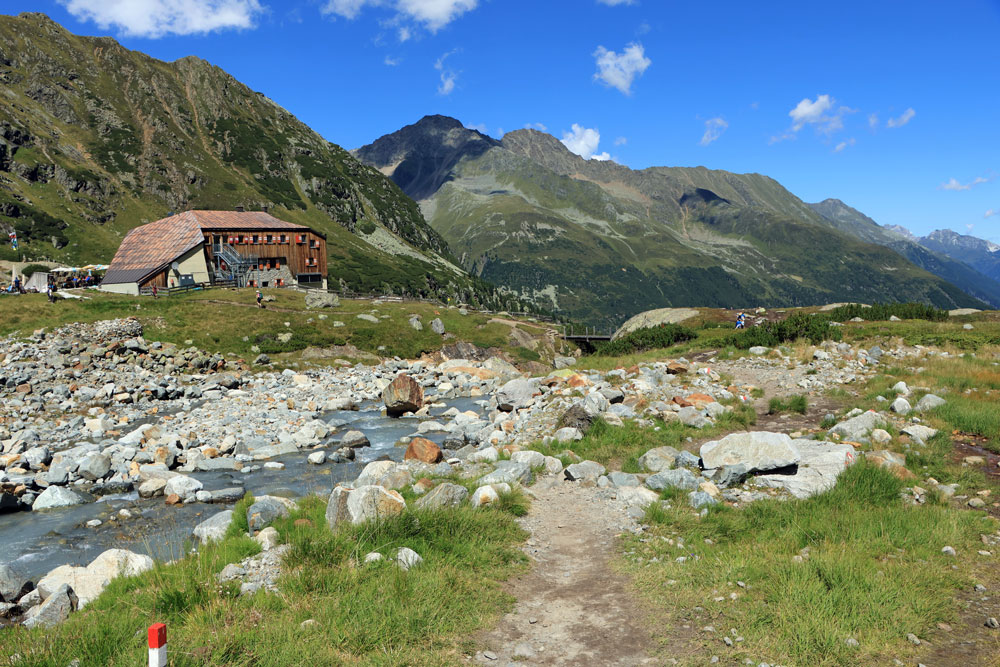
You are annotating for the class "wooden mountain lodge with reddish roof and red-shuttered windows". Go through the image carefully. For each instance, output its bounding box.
[101,210,327,294]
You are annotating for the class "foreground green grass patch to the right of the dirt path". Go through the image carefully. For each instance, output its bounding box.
[624,463,995,665]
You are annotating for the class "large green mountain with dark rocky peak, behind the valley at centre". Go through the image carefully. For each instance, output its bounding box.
[354,116,984,323]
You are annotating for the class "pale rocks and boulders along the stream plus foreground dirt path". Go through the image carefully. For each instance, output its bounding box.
[0,320,1000,665]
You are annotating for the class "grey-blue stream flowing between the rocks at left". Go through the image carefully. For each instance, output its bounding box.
[0,398,481,580]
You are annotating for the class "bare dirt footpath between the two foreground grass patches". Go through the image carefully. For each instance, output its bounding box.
[475,479,655,667]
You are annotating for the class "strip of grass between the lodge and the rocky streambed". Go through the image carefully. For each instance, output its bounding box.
[0,289,545,361]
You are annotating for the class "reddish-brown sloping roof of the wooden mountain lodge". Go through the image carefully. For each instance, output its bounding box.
[103,211,320,285]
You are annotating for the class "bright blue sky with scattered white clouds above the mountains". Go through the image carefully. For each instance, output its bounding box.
[2,0,1000,242]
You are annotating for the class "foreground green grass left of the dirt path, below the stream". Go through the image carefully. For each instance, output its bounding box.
[0,495,525,666]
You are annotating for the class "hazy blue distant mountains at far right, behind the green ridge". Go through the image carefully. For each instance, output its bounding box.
[809,199,1000,307]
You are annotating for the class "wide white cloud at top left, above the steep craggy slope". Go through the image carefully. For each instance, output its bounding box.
[59,0,265,37]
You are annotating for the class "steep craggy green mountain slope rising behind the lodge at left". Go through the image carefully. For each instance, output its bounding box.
[0,14,532,310]
